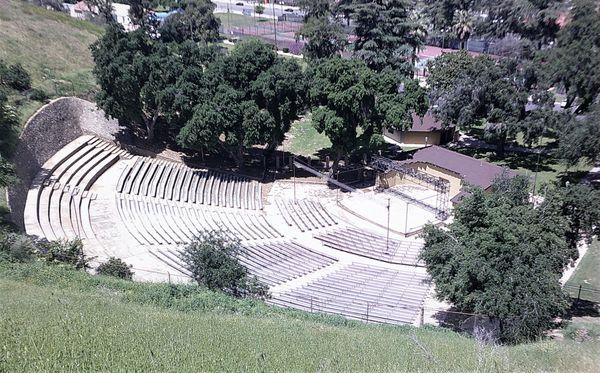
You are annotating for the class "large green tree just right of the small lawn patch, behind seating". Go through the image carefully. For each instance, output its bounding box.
[308,57,427,173]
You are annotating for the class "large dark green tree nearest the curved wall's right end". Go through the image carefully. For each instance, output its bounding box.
[91,25,218,141]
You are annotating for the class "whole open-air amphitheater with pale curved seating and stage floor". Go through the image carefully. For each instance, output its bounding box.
[11,97,448,324]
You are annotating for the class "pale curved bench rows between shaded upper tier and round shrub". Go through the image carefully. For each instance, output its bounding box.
[117,194,283,245]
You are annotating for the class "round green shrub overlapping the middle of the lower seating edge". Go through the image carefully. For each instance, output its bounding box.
[182,232,268,299]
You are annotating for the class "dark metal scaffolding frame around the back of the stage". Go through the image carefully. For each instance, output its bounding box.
[371,157,450,220]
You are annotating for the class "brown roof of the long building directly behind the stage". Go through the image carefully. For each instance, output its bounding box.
[400,145,517,189]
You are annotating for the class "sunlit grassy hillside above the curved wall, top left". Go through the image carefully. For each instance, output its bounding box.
[0,0,102,121]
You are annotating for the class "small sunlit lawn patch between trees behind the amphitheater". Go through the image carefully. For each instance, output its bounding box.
[284,115,331,156]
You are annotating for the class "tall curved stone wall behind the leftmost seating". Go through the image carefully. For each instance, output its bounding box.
[7,97,120,229]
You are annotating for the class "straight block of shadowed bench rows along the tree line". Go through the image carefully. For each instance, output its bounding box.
[117,157,263,210]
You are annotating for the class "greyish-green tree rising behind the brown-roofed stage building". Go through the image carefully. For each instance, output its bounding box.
[427,52,528,155]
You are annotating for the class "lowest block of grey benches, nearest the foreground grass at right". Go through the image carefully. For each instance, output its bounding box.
[269,263,429,324]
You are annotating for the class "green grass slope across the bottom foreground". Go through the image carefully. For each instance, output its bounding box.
[0,263,600,372]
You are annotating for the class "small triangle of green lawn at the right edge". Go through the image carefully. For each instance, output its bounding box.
[567,239,600,302]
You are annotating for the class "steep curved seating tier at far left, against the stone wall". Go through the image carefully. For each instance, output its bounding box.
[24,135,129,240]
